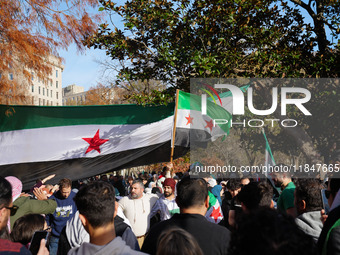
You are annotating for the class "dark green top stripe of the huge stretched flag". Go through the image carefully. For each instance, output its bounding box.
[0,103,174,132]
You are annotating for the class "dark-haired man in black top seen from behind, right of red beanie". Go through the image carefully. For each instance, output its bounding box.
[142,177,230,255]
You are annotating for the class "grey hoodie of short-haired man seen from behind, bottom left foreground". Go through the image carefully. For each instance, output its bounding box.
[67,236,146,255]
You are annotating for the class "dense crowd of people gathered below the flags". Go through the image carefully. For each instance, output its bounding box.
[0,150,340,255]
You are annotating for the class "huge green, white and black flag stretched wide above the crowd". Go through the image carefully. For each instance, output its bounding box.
[0,104,187,189]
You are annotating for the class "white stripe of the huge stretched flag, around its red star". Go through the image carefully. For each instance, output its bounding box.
[0,116,173,165]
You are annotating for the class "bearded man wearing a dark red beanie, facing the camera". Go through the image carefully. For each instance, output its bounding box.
[150,178,179,221]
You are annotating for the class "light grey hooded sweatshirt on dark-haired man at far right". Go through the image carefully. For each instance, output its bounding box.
[295,211,323,242]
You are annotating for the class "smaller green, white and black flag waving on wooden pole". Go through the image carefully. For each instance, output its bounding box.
[175,91,232,147]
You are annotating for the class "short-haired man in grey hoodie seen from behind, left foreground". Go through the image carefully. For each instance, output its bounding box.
[68,181,145,255]
